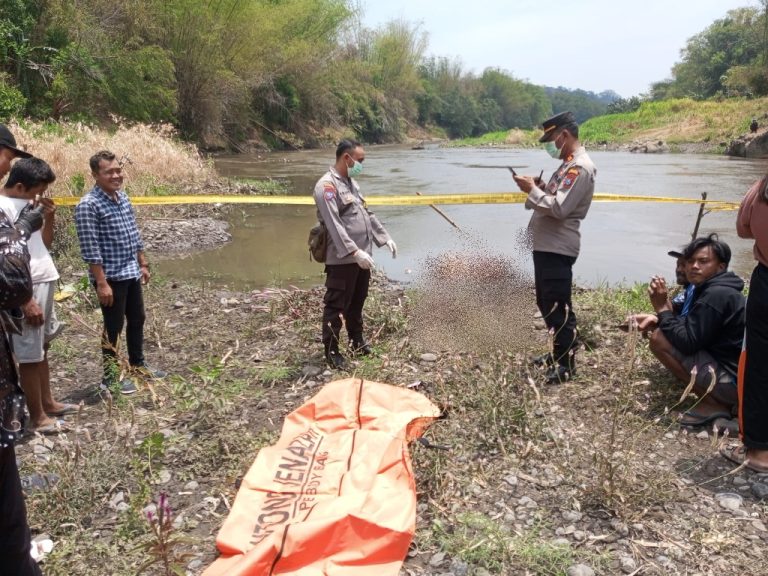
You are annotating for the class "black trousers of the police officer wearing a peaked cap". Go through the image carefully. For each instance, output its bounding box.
[533,251,576,369]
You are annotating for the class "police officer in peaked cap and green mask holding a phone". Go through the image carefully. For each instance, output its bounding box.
[513,112,597,384]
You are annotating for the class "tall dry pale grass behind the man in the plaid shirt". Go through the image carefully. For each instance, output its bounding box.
[9,122,216,196]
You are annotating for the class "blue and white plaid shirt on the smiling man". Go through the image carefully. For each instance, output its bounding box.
[75,186,144,281]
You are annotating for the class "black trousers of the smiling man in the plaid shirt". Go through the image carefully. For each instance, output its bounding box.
[101,278,146,378]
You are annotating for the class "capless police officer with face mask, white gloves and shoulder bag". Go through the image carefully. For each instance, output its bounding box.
[314,140,397,368]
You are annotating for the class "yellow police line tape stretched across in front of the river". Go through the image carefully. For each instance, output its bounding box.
[48,192,739,210]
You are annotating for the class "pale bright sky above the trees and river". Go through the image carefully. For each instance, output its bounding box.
[359,0,760,98]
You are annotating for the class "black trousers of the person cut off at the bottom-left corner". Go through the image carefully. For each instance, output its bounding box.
[0,446,42,576]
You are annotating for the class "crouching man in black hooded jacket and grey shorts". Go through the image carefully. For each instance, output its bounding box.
[634,234,745,428]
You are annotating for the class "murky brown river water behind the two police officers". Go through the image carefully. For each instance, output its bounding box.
[158,146,767,288]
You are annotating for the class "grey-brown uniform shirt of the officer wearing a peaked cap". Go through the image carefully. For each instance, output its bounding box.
[525,146,597,258]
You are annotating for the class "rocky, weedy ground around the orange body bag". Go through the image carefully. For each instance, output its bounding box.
[18,223,768,576]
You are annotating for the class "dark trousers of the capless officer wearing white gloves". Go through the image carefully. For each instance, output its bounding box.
[323,264,371,353]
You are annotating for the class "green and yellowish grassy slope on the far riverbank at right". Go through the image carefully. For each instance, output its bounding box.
[580,98,768,149]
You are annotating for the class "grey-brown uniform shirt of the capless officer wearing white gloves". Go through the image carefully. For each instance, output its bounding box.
[313,167,390,265]
